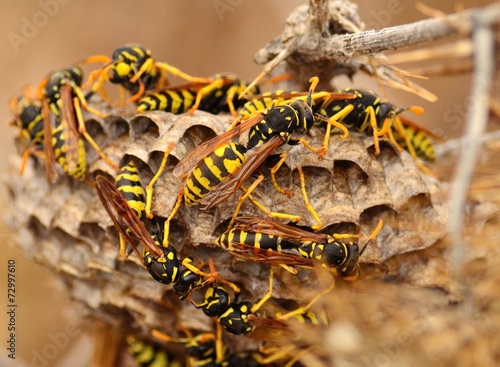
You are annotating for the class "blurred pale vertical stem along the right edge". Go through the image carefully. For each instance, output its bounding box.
[448,13,498,310]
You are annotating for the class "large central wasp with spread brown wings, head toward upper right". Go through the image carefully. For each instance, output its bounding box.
[173,78,348,229]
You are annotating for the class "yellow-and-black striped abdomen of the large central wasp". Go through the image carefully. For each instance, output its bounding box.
[184,143,247,205]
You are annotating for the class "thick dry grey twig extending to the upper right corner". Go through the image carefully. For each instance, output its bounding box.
[312,3,500,63]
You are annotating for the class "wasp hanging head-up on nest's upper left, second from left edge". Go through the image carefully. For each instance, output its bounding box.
[38,65,116,182]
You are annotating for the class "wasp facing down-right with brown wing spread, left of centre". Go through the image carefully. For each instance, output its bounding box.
[95,171,239,299]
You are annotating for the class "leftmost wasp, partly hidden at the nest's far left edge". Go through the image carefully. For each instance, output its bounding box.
[9,86,44,178]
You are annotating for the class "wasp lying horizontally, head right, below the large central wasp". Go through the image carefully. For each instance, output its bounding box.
[215,216,383,280]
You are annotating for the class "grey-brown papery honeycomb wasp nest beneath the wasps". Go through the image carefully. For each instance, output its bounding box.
[4,102,447,356]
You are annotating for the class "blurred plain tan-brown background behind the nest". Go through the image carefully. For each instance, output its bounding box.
[0,0,491,366]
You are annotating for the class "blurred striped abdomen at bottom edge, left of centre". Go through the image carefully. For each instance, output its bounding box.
[126,335,184,367]
